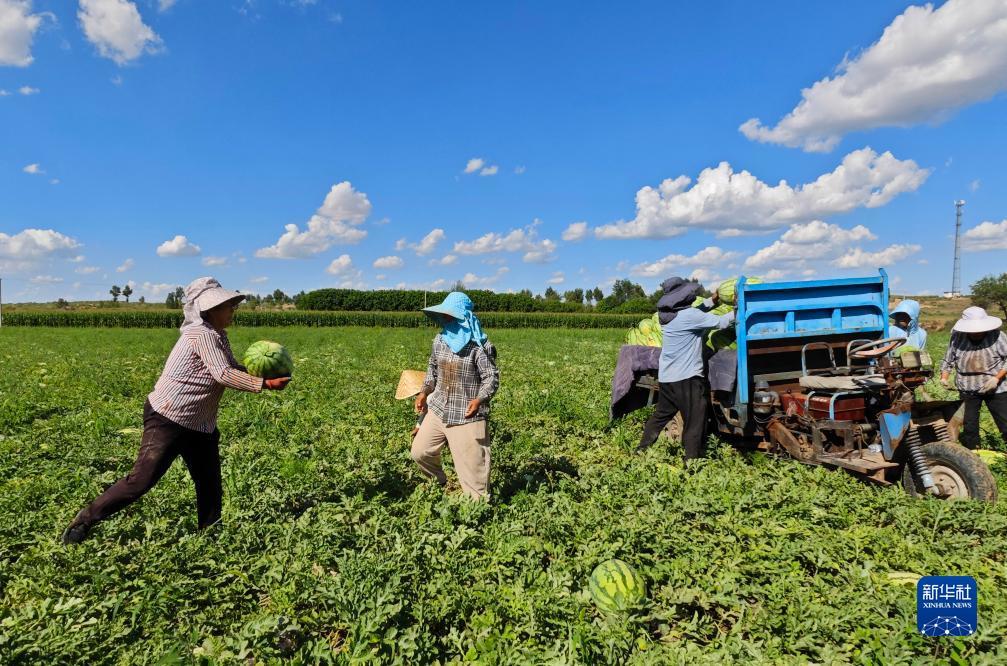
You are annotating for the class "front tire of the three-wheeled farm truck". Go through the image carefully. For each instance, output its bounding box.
[902,441,997,502]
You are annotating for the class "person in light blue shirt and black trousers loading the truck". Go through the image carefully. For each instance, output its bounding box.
[636,293,734,460]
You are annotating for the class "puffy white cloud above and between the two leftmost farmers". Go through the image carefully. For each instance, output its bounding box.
[255,181,371,259]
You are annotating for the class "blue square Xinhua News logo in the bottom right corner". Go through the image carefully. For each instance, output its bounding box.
[916,575,979,637]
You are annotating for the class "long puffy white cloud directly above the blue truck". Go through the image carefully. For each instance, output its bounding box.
[594,148,930,239]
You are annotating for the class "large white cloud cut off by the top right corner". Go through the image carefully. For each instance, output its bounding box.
[739,0,1007,152]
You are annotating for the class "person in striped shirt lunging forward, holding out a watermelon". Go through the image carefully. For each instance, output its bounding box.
[62,277,290,543]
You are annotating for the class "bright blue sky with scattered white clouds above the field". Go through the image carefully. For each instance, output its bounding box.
[0,0,1007,301]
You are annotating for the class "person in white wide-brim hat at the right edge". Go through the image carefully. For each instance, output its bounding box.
[941,306,1007,448]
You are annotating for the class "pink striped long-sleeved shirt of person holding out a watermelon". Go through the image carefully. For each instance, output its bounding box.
[147,322,263,432]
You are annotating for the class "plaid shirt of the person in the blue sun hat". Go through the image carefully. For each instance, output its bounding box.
[423,334,499,425]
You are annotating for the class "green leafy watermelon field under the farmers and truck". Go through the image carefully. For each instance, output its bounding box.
[0,327,1007,665]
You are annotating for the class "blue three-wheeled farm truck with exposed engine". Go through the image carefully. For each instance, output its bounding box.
[632,270,997,502]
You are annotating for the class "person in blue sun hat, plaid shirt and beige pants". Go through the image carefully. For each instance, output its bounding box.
[411,291,499,500]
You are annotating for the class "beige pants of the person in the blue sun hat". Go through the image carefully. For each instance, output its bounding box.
[411,412,489,500]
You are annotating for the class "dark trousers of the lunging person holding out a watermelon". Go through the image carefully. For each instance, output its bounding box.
[74,401,224,528]
